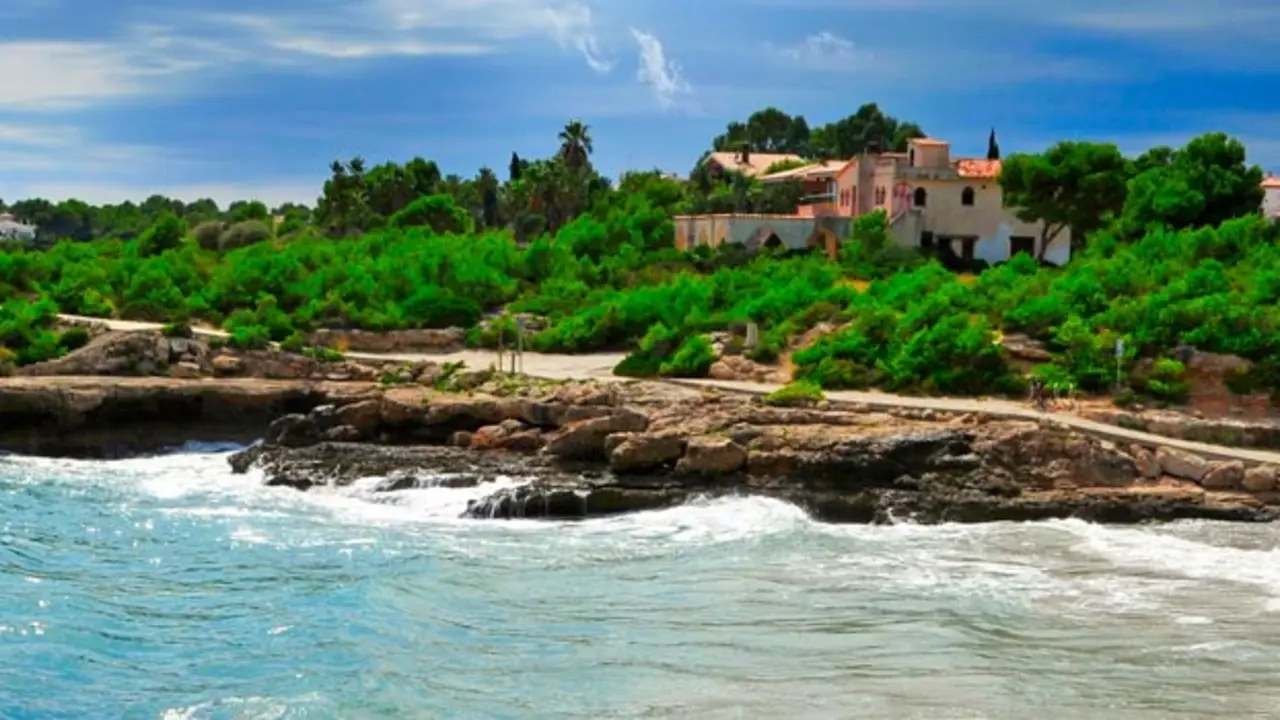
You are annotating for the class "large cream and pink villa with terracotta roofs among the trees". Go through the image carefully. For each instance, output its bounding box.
[676,138,1071,265]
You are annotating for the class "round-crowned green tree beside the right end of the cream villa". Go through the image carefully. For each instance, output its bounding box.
[1000,141,1126,259]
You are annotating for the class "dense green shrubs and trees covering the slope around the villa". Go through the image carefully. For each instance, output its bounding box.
[0,106,1280,400]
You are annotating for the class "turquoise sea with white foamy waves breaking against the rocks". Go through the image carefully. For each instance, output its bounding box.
[0,452,1280,720]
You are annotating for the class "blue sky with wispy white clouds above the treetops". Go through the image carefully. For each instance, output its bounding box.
[0,0,1280,204]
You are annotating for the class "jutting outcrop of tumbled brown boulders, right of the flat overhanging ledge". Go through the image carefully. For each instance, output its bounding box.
[222,383,1280,523]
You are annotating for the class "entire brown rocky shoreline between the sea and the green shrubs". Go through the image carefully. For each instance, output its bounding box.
[0,333,1280,523]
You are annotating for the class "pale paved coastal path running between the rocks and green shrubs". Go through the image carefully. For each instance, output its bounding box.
[61,315,1280,465]
